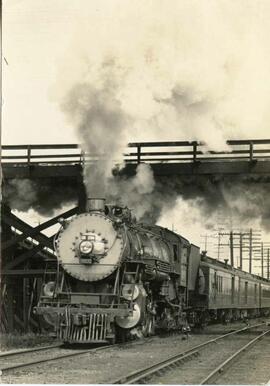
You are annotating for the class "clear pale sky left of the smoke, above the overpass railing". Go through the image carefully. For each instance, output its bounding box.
[2,0,77,144]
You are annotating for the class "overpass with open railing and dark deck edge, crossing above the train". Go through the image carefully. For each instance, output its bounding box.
[1,139,270,179]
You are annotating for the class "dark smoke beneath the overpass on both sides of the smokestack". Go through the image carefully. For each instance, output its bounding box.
[3,171,270,235]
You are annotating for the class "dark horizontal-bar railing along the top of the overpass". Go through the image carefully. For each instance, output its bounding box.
[1,139,270,166]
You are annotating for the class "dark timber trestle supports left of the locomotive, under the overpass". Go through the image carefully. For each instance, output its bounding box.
[0,204,79,332]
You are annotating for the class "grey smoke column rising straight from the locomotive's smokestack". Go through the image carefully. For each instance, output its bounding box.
[62,79,128,197]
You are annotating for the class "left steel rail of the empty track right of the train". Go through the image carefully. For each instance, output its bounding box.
[111,322,270,385]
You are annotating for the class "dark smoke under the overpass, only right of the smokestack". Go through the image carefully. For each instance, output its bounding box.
[108,170,270,231]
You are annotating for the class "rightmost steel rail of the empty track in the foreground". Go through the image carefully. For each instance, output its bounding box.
[200,329,270,385]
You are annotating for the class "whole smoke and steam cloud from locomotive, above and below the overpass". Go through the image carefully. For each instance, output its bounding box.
[55,0,270,244]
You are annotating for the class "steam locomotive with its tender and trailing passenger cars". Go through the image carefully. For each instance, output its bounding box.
[36,199,270,343]
